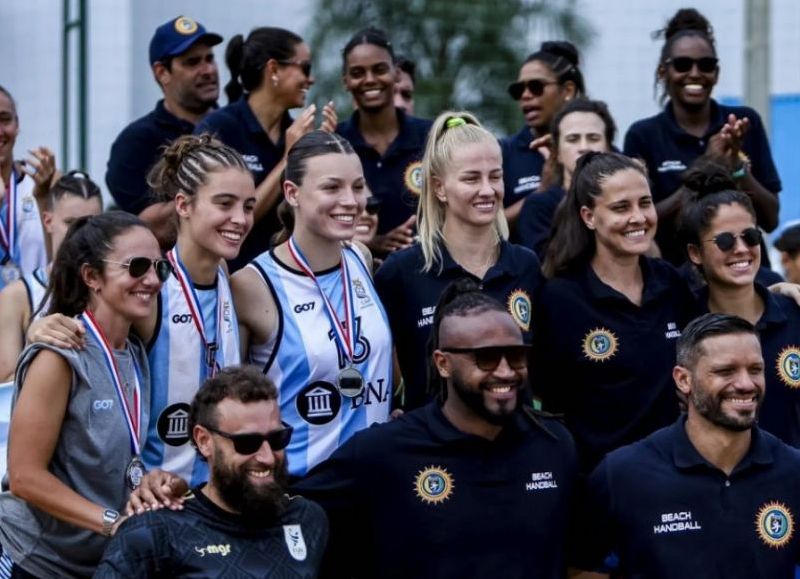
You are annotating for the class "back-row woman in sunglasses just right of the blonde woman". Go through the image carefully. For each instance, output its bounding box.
[500,41,585,225]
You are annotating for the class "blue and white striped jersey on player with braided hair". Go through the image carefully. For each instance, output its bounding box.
[142,269,241,486]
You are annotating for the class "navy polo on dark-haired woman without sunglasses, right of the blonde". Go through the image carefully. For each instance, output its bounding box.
[528,257,696,472]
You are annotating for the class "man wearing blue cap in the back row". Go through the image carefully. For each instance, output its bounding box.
[106,16,222,246]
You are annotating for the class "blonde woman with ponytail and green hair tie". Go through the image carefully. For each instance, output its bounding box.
[375,112,540,409]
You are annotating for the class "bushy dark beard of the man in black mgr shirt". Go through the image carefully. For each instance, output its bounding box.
[211,448,289,526]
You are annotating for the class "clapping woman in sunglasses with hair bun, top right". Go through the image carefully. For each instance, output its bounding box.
[624,8,781,265]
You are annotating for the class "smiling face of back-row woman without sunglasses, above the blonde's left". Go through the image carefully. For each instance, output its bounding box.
[343,44,397,112]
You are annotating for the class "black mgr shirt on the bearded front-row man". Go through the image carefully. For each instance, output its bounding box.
[94,489,328,579]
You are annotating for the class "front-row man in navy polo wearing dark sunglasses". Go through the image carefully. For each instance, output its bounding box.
[296,280,577,579]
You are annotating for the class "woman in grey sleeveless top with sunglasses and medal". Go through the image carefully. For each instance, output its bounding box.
[0,212,170,577]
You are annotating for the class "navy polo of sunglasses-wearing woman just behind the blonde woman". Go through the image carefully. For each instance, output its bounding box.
[500,125,544,207]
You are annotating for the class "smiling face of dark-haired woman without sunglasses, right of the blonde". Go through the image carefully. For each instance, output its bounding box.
[581,169,658,257]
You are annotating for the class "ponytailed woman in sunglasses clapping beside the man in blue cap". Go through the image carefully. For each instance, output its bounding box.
[195,27,336,272]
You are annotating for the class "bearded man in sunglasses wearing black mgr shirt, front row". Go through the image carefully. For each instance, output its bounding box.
[95,367,328,578]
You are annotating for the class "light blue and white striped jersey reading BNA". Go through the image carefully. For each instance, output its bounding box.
[247,247,392,476]
